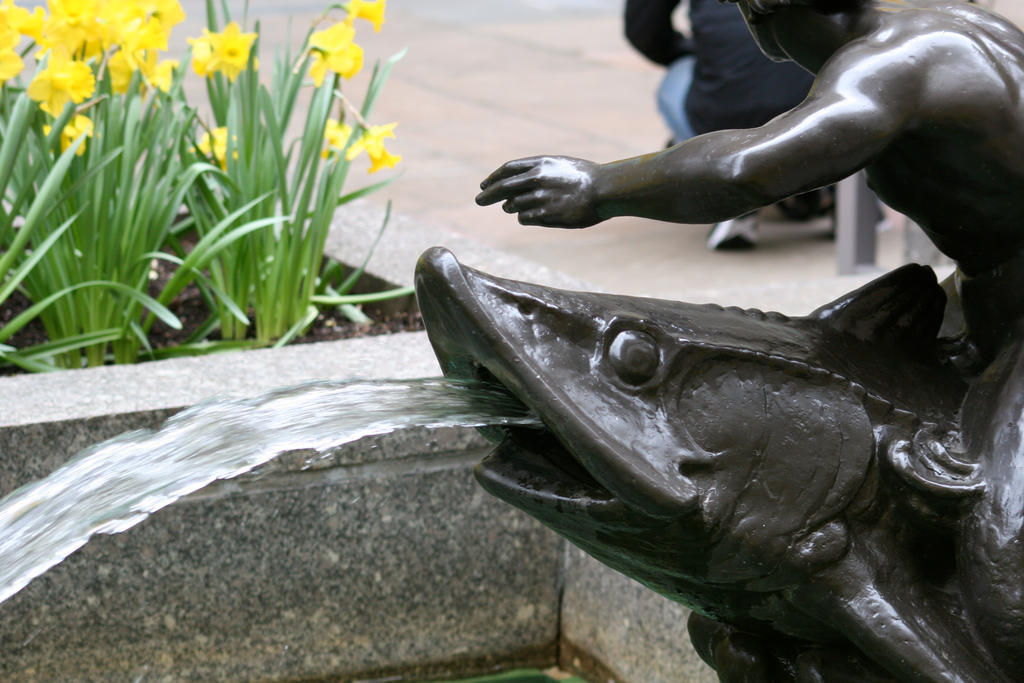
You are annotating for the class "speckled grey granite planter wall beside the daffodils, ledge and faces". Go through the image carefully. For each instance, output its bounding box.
[0,205,714,683]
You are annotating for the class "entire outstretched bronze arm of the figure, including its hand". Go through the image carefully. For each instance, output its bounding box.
[476,43,918,227]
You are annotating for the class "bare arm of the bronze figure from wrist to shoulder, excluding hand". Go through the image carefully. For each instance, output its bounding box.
[595,81,908,223]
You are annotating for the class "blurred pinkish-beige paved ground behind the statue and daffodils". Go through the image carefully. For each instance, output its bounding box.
[176,0,1024,297]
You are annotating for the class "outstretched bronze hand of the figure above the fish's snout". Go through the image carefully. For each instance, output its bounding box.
[476,157,602,227]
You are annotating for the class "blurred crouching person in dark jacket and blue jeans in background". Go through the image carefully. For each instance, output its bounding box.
[625,0,831,249]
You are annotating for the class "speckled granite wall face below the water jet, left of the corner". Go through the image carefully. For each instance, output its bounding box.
[0,423,558,681]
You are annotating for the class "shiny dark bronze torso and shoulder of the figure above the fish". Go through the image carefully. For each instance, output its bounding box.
[865,3,1024,272]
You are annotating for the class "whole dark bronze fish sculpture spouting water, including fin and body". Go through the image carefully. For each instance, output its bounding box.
[416,248,1024,681]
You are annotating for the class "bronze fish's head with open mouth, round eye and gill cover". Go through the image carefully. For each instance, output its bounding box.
[416,248,956,598]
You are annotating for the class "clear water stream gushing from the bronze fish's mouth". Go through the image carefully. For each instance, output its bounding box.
[0,379,539,602]
